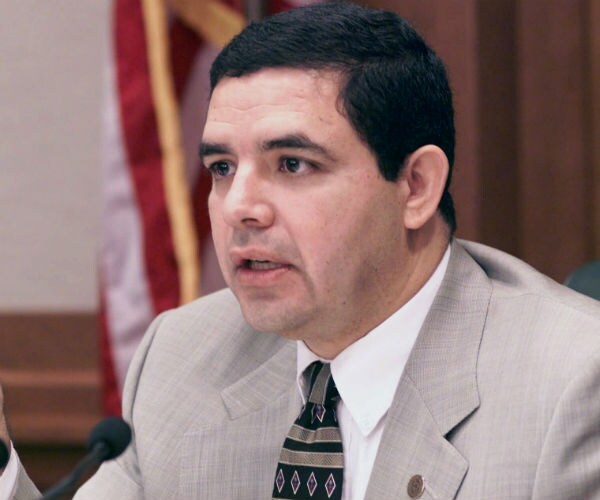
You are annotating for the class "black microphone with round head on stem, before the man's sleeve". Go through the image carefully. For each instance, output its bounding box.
[42,417,131,500]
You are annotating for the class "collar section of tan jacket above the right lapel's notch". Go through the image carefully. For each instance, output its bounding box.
[404,241,492,435]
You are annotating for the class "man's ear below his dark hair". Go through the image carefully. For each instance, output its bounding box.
[399,144,450,229]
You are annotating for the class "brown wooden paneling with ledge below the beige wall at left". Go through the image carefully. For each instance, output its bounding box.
[0,313,102,488]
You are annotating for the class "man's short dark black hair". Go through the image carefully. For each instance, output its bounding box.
[210,2,456,233]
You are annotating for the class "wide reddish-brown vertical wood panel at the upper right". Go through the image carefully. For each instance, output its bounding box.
[517,0,592,279]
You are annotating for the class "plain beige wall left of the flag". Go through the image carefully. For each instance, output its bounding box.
[0,0,108,311]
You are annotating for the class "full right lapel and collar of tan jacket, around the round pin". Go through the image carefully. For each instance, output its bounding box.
[366,242,491,500]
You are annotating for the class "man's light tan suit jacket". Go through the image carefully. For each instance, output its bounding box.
[11,242,600,500]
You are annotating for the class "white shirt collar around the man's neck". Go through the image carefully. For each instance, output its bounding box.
[297,247,450,436]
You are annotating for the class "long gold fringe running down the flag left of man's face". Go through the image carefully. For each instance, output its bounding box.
[142,0,200,304]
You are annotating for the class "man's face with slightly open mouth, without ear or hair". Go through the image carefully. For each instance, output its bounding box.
[202,69,407,357]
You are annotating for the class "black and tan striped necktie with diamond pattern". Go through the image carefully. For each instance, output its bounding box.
[273,361,344,500]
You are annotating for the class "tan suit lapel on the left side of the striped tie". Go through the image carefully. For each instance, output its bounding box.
[180,333,300,500]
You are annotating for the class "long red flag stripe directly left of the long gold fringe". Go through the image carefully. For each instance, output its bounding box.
[114,0,179,313]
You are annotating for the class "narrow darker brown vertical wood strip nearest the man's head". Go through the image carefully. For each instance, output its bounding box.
[475,0,519,254]
